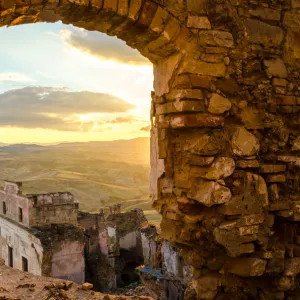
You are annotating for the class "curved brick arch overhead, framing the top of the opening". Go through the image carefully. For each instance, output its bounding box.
[0,0,192,63]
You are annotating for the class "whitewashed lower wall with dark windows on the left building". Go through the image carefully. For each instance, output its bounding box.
[0,216,43,275]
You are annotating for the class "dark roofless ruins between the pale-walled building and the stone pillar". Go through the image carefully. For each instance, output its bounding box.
[78,209,191,300]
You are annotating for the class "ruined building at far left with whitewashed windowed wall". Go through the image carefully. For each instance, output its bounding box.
[0,182,85,283]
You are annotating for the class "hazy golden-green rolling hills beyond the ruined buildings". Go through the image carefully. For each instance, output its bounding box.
[0,138,160,224]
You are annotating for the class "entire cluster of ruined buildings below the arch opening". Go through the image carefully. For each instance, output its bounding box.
[0,182,188,300]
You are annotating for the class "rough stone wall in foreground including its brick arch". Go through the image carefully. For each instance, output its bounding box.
[0,0,300,299]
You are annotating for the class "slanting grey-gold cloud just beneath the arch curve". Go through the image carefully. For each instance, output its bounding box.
[60,27,151,65]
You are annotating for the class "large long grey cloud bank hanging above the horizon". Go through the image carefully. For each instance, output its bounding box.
[0,87,134,131]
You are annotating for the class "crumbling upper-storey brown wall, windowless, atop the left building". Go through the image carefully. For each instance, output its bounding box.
[26,192,79,226]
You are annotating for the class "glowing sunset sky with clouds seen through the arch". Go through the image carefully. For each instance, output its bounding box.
[0,23,153,143]
